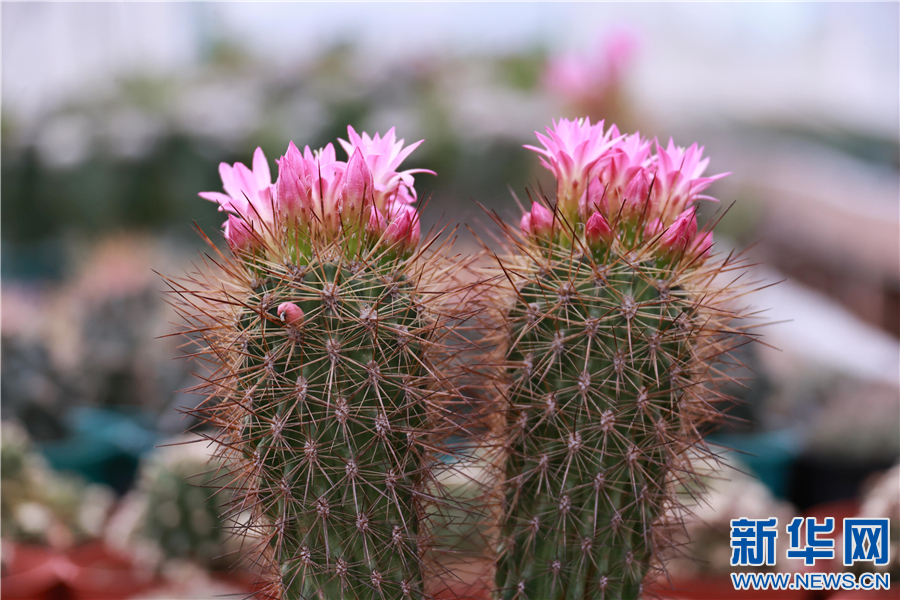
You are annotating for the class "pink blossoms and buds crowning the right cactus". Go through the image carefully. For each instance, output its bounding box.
[521,119,728,256]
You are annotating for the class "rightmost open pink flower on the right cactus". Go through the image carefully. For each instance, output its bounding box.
[653,139,730,221]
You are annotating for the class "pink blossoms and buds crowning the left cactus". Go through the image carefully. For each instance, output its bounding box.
[200,127,434,252]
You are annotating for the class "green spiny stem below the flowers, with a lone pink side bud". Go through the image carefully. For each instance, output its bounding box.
[238,257,428,598]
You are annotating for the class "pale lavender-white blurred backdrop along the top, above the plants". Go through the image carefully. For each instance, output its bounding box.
[2,2,900,136]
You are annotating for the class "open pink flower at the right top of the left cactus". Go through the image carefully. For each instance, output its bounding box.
[338,126,435,210]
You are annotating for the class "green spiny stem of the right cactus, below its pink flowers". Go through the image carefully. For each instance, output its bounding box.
[498,250,693,599]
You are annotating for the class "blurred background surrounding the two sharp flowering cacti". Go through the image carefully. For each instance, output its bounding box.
[0,3,900,599]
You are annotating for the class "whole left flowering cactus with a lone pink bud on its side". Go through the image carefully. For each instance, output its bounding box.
[164,127,464,600]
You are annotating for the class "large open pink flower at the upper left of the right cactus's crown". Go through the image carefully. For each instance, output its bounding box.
[525,118,620,215]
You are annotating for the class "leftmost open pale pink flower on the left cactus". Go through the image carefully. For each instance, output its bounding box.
[199,148,274,223]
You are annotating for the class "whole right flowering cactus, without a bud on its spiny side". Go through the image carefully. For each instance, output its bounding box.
[496,120,747,600]
